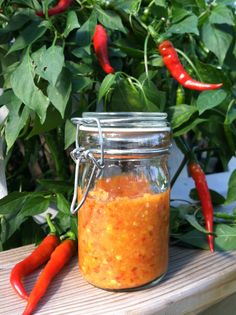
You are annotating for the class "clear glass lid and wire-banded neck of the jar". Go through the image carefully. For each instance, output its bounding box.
[72,112,171,158]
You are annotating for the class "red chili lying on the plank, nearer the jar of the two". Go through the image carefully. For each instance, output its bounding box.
[22,239,76,315]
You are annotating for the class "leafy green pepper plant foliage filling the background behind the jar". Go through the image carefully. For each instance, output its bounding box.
[0,0,236,250]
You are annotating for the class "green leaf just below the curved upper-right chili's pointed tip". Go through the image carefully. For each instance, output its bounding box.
[196,90,227,115]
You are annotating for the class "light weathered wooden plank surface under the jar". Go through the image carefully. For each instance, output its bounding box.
[0,245,236,315]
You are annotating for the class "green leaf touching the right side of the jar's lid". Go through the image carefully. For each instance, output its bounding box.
[169,104,197,129]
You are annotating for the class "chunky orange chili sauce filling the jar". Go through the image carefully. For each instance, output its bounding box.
[78,174,169,290]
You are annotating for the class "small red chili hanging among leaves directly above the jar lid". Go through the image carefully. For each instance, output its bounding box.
[93,25,115,73]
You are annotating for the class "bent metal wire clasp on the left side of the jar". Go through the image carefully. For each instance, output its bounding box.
[70,118,104,214]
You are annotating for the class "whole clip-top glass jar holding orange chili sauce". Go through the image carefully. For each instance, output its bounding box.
[71,112,171,291]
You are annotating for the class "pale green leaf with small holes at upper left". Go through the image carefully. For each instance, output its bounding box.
[32,45,64,86]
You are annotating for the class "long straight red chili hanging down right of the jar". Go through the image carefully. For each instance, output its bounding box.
[188,162,214,252]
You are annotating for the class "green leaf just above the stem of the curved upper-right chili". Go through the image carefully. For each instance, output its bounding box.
[167,15,199,35]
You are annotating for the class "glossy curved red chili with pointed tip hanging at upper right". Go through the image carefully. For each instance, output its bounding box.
[159,40,223,91]
